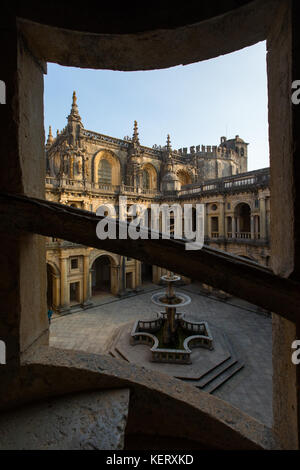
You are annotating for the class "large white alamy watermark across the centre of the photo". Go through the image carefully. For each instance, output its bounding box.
[96,196,204,250]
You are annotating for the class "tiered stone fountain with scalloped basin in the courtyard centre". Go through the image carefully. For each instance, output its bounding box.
[130,272,213,364]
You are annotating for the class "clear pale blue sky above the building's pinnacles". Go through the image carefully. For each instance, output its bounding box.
[45,42,269,170]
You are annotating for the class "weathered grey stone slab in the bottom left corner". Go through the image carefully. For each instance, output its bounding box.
[0,389,129,450]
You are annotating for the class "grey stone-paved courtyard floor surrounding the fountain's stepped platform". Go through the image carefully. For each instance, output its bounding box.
[50,285,272,426]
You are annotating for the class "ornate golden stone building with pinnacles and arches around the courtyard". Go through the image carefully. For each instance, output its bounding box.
[46,92,270,312]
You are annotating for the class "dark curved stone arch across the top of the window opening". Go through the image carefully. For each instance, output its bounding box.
[17,0,278,70]
